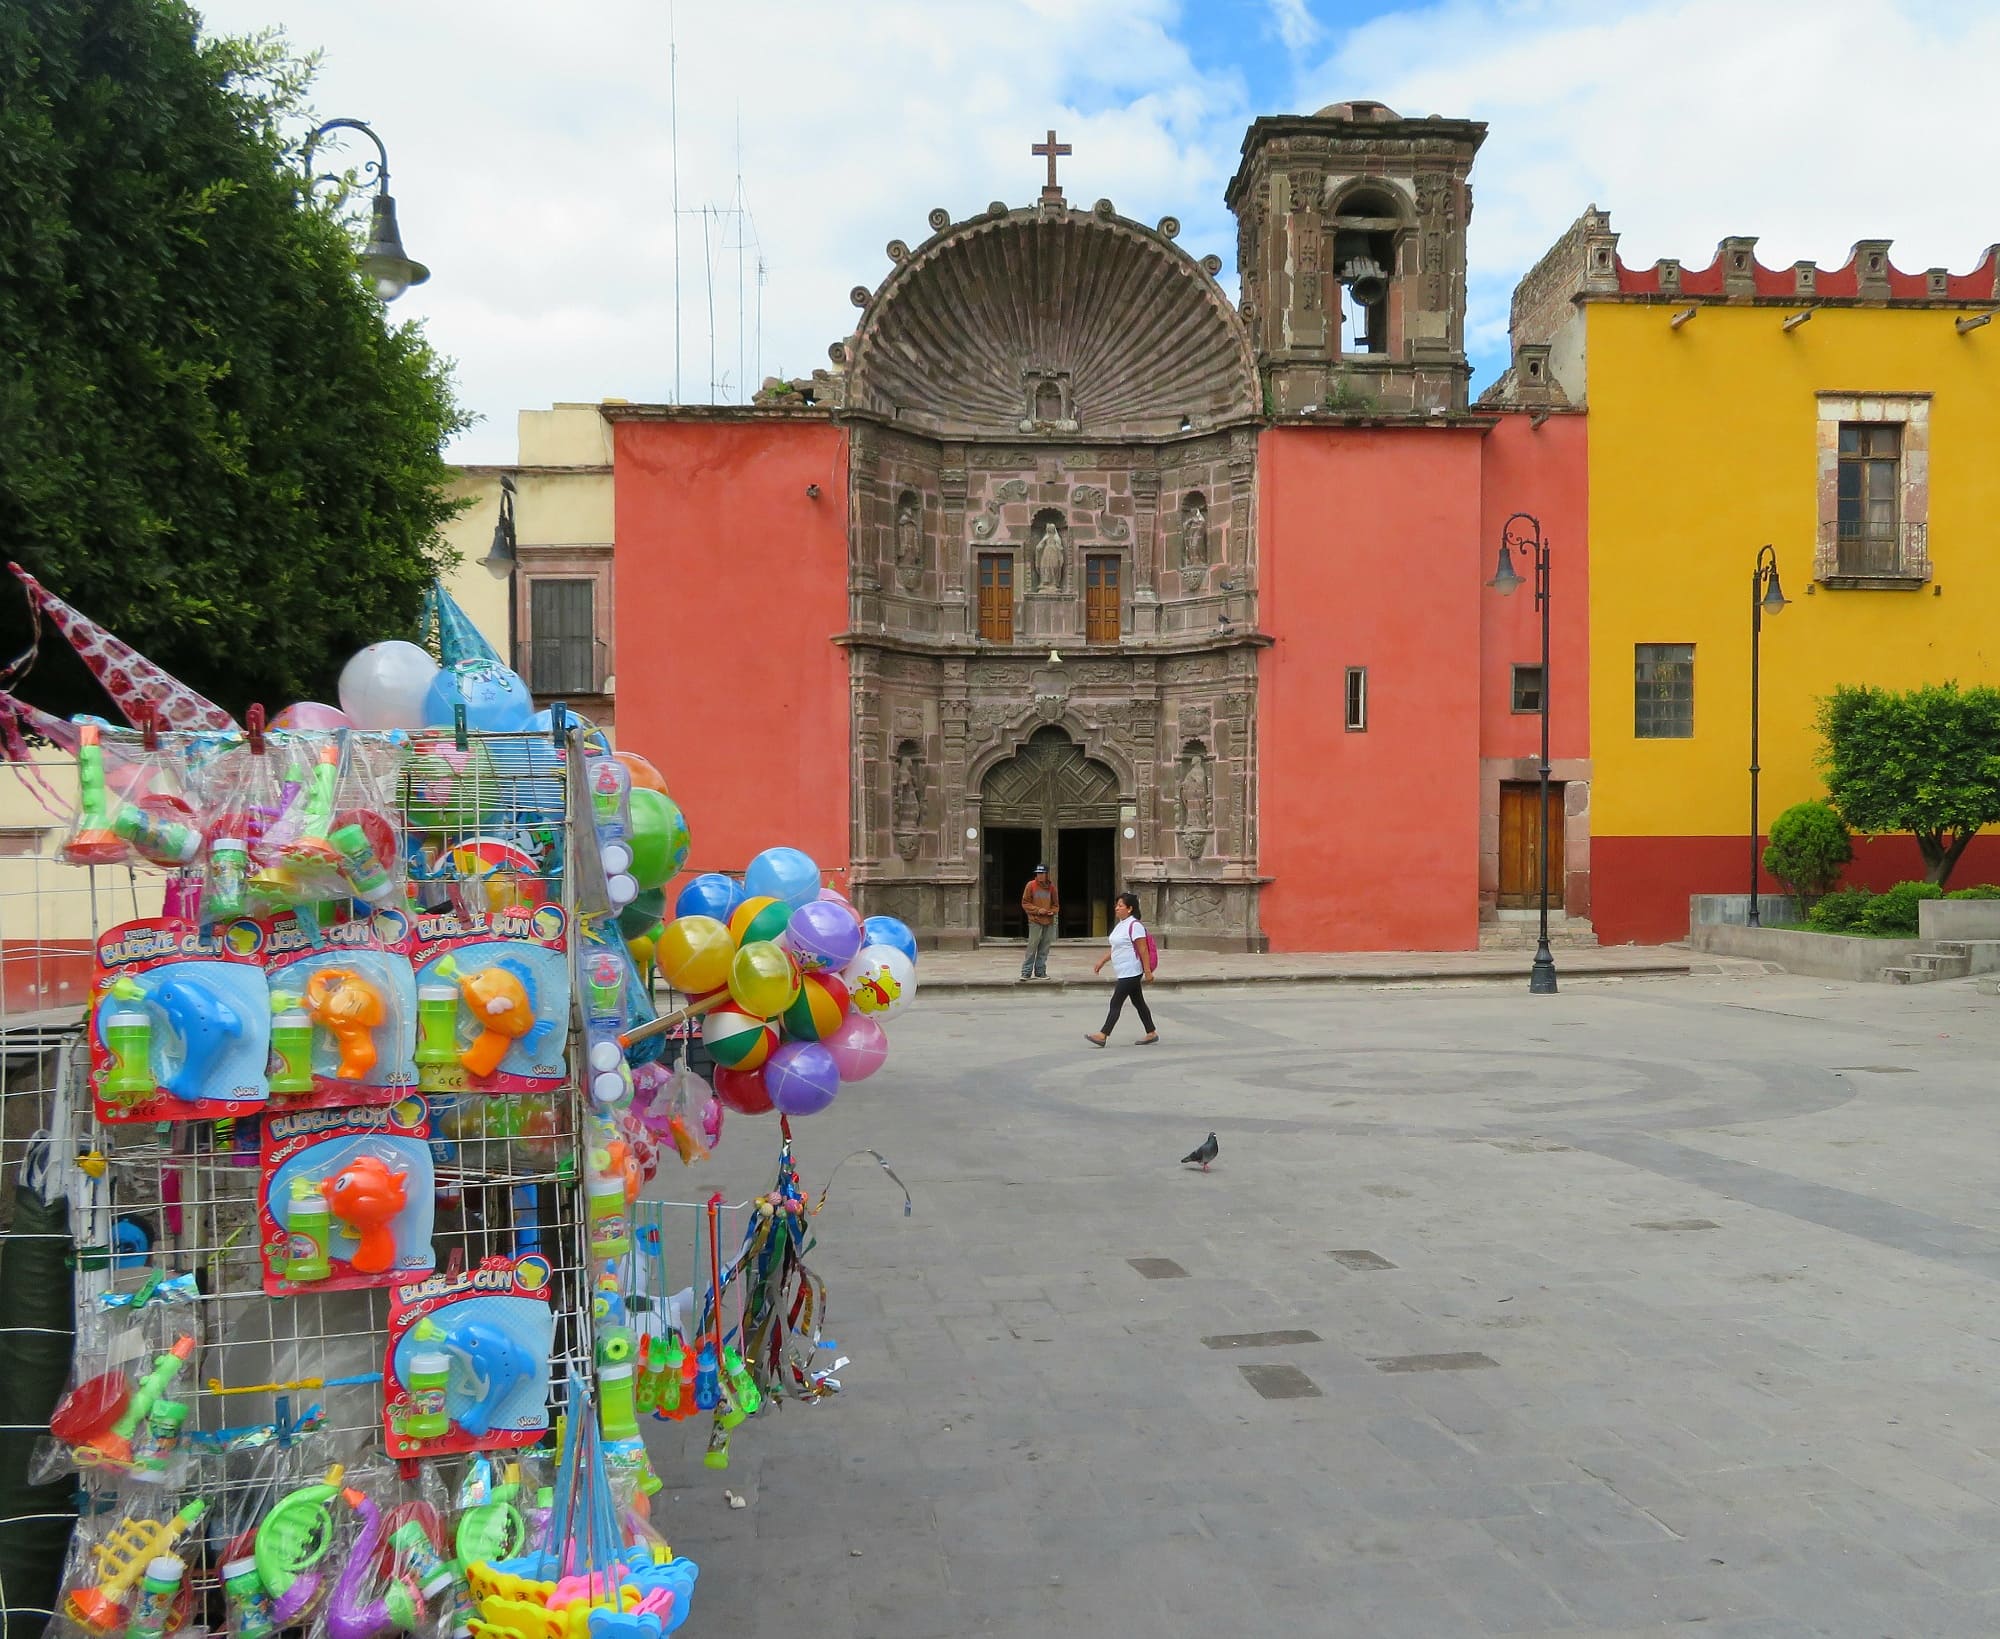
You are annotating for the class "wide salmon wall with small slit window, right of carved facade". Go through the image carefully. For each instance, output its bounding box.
[1258,426,1492,951]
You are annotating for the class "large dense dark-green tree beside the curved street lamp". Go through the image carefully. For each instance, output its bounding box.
[0,0,464,712]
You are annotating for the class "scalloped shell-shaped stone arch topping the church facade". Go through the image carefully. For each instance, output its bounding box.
[846,210,1260,438]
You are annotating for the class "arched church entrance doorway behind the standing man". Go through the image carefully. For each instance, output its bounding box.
[980,728,1120,939]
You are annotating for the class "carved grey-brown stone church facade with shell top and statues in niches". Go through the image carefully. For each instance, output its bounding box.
[842,188,1262,949]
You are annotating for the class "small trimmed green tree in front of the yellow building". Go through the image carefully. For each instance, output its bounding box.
[1820,684,2000,885]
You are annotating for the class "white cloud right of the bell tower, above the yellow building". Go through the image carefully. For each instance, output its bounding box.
[1294,0,2000,373]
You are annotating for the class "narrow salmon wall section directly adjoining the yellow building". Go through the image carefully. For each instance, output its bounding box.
[1480,412,1590,758]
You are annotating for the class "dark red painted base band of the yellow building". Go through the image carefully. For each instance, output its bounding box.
[1590,831,2000,945]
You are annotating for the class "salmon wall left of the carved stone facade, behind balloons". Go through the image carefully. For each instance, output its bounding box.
[612,422,848,907]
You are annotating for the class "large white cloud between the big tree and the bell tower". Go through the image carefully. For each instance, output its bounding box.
[198,0,1248,462]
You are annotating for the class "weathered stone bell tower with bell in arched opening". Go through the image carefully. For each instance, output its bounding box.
[1224,102,1486,416]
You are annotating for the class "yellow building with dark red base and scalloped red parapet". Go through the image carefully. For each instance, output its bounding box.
[1494,208,2000,941]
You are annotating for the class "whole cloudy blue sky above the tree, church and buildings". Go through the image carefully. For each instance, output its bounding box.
[194,0,2000,464]
